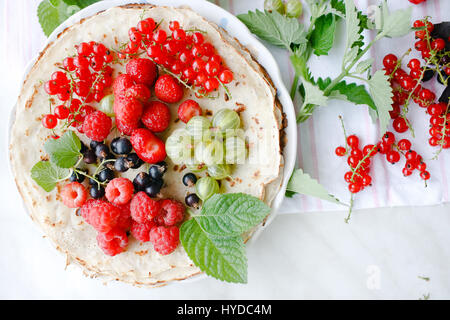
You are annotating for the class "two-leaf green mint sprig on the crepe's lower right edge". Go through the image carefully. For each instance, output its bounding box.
[180,193,270,283]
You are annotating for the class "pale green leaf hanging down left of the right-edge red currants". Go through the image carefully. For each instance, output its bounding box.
[368,70,394,135]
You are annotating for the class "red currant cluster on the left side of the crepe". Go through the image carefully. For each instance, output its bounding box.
[42,42,114,132]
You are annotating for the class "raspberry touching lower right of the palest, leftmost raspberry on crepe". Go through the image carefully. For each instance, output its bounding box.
[81,200,121,233]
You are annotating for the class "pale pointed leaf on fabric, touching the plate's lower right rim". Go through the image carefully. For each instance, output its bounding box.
[287,169,346,205]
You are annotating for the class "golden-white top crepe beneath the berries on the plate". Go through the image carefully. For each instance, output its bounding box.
[10,4,283,286]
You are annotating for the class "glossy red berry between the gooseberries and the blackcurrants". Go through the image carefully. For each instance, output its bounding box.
[130,129,167,163]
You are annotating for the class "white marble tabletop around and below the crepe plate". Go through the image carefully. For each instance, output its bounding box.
[0,0,450,299]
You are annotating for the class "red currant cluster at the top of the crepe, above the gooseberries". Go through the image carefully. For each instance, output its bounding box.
[119,18,234,97]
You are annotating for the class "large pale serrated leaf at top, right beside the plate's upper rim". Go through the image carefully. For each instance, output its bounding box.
[237,10,307,50]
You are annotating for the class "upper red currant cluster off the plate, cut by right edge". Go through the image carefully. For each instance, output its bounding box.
[383,19,450,154]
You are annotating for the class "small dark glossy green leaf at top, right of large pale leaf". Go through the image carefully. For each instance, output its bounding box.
[310,13,336,56]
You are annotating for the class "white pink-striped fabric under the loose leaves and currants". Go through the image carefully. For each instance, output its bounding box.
[0,0,450,213]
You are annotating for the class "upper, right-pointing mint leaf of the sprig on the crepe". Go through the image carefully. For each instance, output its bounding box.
[198,193,270,236]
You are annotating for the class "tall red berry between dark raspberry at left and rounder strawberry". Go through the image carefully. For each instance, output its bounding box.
[114,97,144,135]
